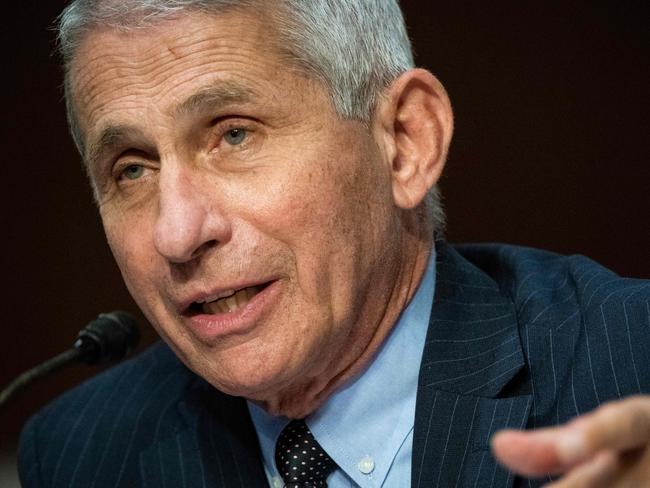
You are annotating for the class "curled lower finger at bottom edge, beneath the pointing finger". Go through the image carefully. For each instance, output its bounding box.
[544,451,621,488]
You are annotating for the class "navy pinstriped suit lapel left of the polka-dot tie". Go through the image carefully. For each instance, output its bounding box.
[140,380,267,488]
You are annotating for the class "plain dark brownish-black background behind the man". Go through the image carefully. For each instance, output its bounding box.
[0,0,650,449]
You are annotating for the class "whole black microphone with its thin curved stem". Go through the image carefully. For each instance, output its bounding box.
[0,311,140,410]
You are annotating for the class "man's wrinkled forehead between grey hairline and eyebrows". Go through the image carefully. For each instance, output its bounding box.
[68,11,287,151]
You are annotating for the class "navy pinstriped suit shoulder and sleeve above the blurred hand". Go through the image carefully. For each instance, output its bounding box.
[450,244,650,418]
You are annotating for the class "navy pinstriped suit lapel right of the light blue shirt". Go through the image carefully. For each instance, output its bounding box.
[411,242,531,488]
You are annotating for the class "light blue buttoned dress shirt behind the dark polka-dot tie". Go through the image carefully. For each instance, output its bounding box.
[248,250,436,488]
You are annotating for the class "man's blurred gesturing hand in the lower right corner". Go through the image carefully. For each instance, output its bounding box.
[492,396,650,488]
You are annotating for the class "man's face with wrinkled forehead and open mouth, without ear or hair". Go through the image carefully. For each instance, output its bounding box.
[72,13,400,408]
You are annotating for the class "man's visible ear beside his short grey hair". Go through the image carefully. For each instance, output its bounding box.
[375,69,454,209]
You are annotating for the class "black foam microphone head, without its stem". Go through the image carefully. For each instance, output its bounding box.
[74,311,140,364]
